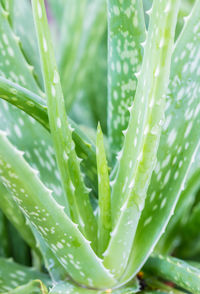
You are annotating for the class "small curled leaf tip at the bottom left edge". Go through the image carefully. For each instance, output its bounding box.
[2,280,48,294]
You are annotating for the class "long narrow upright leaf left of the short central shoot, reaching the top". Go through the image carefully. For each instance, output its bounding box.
[32,0,97,247]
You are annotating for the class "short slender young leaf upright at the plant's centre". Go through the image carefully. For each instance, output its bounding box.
[96,124,112,255]
